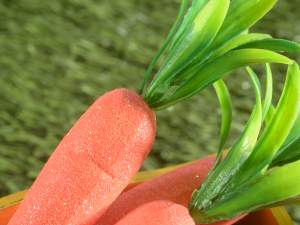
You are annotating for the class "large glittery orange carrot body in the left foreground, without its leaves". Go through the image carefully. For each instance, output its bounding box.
[9,89,156,225]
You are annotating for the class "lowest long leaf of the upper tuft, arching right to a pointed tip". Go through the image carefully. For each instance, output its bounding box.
[150,49,292,109]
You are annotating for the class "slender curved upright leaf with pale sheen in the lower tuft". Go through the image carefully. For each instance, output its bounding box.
[190,71,262,215]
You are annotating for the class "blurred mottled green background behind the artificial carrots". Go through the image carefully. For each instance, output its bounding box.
[0,0,300,221]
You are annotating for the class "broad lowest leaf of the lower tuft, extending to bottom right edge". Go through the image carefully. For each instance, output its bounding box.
[202,161,300,222]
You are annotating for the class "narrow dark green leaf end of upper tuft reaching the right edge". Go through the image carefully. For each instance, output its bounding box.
[238,38,300,54]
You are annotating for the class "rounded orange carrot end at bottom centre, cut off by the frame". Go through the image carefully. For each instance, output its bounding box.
[116,201,195,225]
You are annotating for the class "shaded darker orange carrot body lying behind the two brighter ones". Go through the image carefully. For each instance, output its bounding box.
[97,157,244,225]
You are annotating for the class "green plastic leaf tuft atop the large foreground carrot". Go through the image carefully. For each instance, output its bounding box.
[140,0,300,110]
